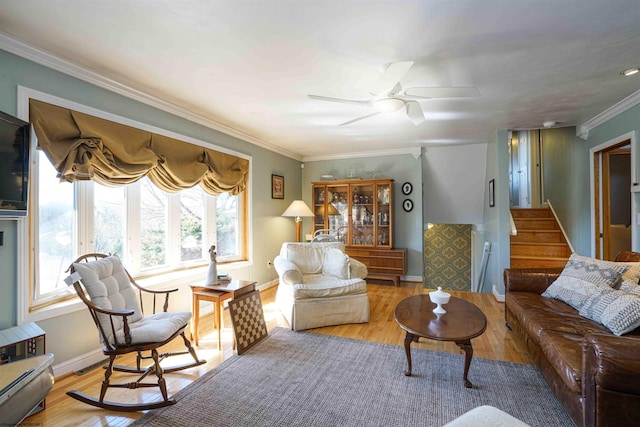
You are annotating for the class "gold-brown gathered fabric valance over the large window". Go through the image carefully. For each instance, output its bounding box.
[29,99,249,195]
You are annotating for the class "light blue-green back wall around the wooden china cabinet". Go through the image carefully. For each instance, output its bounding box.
[302,154,424,280]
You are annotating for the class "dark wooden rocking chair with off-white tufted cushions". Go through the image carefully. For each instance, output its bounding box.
[67,254,205,412]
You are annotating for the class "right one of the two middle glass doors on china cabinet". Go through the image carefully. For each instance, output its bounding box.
[351,184,376,246]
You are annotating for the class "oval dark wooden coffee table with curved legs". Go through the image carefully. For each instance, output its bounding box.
[394,294,487,388]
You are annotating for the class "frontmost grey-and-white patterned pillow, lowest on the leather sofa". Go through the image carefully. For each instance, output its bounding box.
[580,285,640,336]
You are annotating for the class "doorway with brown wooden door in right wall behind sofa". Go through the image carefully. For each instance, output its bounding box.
[593,139,632,261]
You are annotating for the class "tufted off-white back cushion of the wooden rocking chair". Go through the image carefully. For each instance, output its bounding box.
[73,255,143,340]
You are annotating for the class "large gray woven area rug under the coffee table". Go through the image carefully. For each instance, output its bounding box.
[134,328,574,427]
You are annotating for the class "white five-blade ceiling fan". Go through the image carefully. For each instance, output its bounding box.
[308,61,480,126]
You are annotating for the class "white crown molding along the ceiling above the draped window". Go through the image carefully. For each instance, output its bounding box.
[0,32,302,161]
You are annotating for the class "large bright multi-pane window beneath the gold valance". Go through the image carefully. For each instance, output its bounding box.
[31,147,246,308]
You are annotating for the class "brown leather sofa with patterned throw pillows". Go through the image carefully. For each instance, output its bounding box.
[504,252,640,426]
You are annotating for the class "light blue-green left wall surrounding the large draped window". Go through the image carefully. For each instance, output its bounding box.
[0,50,302,363]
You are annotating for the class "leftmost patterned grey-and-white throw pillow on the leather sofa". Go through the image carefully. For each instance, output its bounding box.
[542,254,629,310]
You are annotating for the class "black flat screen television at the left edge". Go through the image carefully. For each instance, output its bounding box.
[0,111,31,216]
